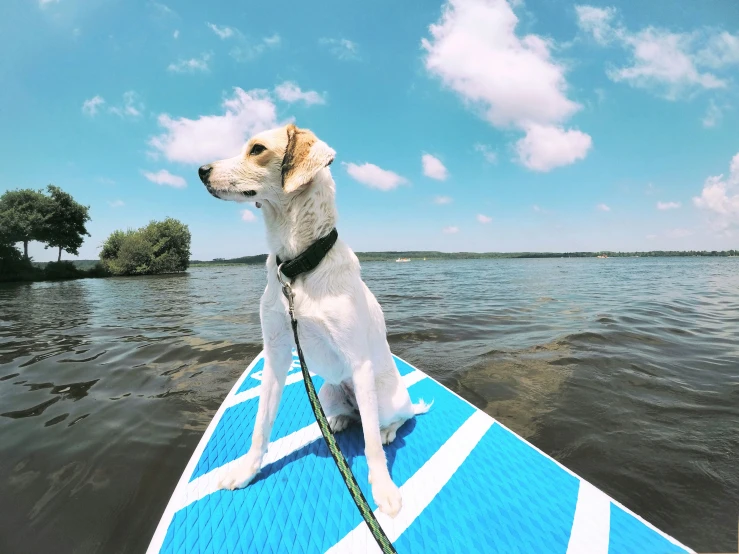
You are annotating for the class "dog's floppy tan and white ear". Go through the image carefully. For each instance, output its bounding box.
[282,123,336,192]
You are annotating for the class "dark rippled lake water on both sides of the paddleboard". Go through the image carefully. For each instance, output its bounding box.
[0,258,739,554]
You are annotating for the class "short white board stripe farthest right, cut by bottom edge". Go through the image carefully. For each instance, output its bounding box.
[567,479,611,554]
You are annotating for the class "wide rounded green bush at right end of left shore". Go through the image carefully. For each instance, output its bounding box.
[100,218,190,275]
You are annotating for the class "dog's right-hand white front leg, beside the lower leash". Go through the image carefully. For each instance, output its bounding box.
[352,361,403,517]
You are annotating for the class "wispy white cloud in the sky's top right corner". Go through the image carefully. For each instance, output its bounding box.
[575,6,739,100]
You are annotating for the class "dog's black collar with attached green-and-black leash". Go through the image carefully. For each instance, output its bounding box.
[277,229,397,554]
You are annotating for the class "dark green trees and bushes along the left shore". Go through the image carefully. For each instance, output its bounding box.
[0,185,191,281]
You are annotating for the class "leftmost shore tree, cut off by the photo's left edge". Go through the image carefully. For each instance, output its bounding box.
[0,189,50,260]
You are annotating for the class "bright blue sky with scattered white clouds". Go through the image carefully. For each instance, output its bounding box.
[0,0,739,261]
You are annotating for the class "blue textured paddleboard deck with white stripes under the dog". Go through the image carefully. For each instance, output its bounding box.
[147,353,693,554]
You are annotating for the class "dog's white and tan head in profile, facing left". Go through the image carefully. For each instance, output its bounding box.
[198,123,336,207]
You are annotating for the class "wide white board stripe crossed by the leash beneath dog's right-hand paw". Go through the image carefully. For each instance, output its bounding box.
[326,411,494,554]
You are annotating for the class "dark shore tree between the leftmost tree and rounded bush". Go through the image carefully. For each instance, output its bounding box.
[42,185,90,261]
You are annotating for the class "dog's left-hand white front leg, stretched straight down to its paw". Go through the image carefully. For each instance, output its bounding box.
[220,326,293,490]
